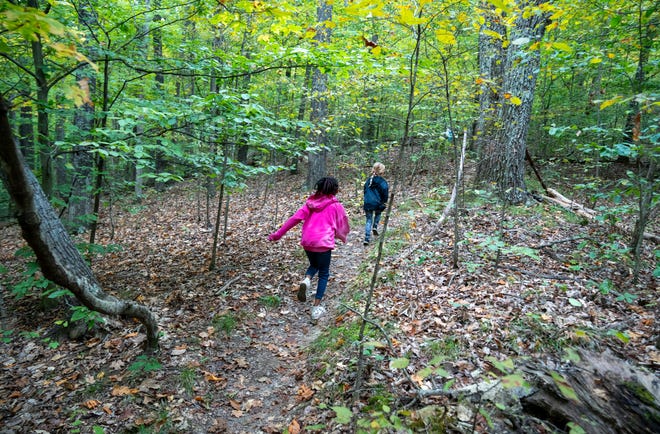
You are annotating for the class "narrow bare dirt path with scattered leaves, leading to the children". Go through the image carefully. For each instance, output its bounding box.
[197,228,365,434]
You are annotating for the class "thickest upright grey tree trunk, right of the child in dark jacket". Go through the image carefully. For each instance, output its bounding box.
[478,0,547,204]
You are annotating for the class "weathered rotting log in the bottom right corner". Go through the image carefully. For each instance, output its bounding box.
[520,351,660,434]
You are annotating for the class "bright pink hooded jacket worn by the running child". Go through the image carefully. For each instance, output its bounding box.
[268,195,350,252]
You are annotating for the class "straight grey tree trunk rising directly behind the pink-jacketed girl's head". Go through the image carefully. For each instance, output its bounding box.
[307,0,332,189]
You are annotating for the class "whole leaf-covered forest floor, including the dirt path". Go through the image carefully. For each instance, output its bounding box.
[0,164,660,434]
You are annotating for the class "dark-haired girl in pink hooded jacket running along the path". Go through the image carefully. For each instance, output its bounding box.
[268,177,350,321]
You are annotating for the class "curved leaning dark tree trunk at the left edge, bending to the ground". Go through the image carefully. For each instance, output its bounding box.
[0,97,158,349]
